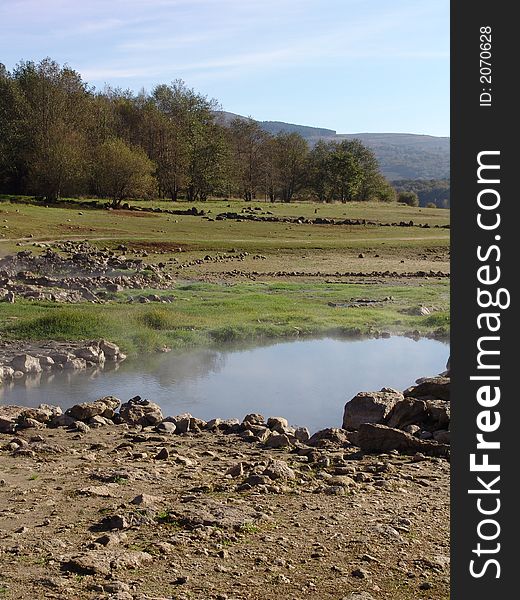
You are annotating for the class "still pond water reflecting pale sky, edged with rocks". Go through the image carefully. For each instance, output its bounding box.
[0,337,449,431]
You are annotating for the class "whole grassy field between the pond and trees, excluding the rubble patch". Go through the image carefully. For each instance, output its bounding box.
[0,198,449,353]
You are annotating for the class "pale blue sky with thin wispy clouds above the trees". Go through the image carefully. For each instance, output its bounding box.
[0,0,449,136]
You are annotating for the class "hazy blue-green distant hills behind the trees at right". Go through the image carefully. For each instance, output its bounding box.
[218,111,450,181]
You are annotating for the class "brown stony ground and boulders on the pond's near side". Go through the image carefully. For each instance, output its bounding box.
[0,374,450,600]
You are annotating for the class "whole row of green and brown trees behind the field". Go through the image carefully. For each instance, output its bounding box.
[0,58,396,207]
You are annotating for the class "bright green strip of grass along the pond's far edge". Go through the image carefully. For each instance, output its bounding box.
[0,281,449,355]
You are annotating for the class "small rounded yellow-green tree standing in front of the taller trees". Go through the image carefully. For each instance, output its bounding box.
[94,138,156,208]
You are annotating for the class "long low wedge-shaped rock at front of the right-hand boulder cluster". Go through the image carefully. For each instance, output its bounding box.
[358,423,449,456]
